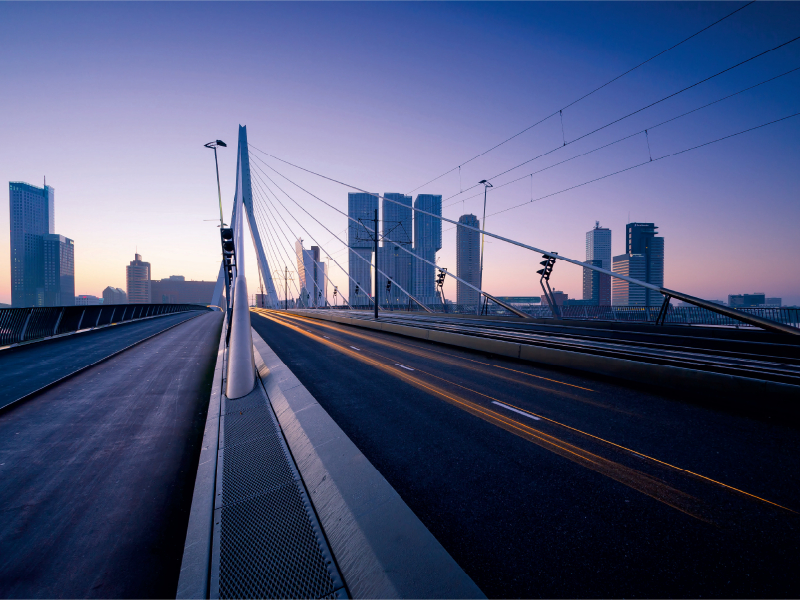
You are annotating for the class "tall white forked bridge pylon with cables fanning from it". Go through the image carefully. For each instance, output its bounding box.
[211,125,279,309]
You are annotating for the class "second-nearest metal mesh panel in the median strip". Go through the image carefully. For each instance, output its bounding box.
[222,434,294,505]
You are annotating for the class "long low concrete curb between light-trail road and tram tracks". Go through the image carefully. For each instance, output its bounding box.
[290,311,800,410]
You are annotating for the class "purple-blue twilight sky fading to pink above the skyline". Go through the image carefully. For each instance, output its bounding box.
[0,2,800,304]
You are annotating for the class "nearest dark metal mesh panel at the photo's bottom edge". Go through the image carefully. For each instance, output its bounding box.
[219,482,337,598]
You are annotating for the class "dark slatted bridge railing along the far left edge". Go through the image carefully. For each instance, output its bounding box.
[0,304,209,346]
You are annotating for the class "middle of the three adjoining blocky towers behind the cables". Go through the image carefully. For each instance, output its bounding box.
[378,192,413,304]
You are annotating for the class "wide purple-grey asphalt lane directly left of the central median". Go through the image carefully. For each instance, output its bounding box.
[0,312,222,598]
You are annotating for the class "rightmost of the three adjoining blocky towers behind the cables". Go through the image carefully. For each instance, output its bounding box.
[412,194,442,304]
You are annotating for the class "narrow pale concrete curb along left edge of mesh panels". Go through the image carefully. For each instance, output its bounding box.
[175,317,227,598]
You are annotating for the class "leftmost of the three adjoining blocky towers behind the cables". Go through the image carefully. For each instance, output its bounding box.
[347,192,378,306]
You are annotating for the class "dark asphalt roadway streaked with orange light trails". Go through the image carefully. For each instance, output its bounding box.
[253,313,800,597]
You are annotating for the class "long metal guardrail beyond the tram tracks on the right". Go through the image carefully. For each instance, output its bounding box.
[296,303,800,328]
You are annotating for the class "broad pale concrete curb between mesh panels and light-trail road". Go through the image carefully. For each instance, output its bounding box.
[253,330,485,598]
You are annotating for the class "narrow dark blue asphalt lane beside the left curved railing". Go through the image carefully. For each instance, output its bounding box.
[0,311,209,407]
